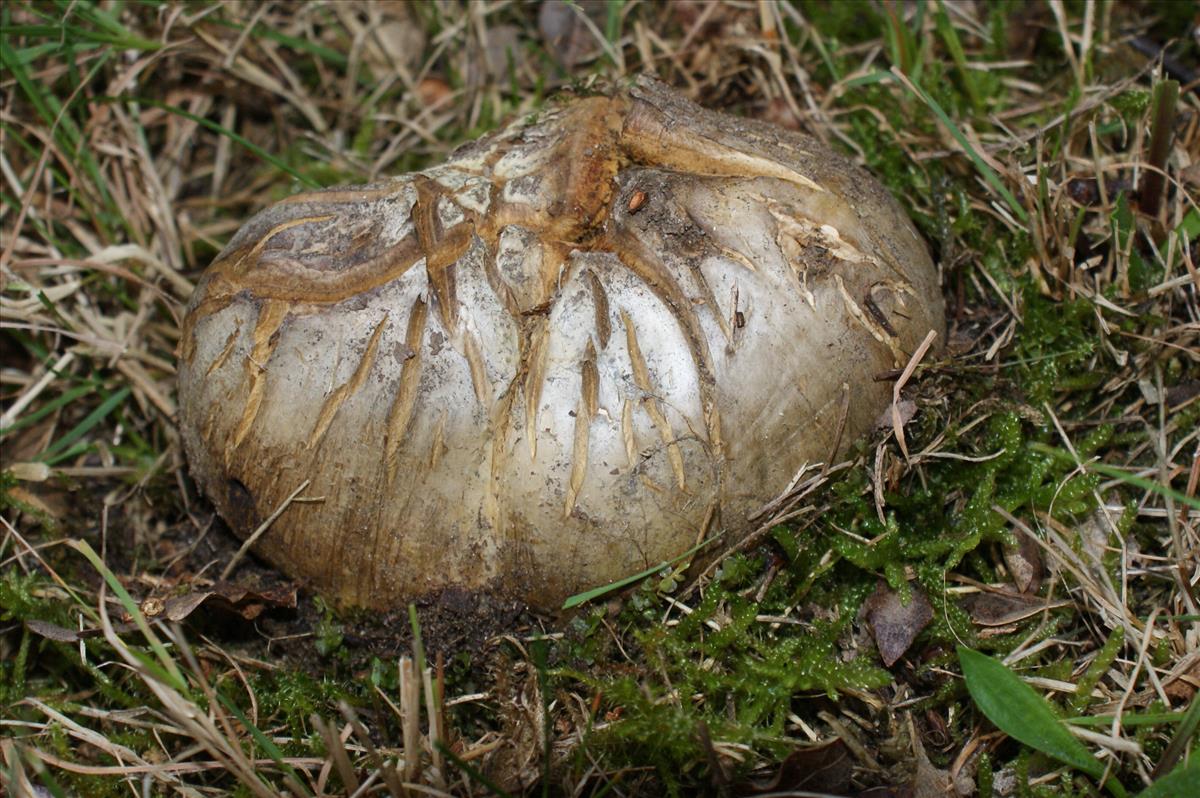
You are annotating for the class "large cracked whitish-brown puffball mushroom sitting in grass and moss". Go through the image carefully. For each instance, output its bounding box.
[179,78,943,608]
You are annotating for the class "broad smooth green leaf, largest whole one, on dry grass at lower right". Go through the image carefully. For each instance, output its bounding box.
[959,646,1104,779]
